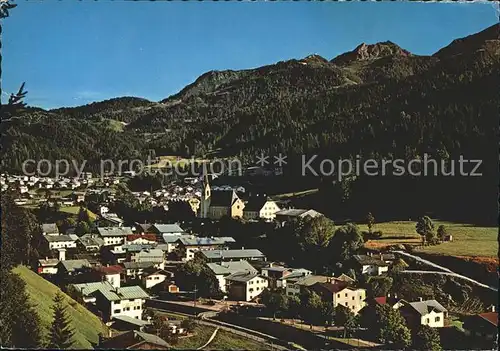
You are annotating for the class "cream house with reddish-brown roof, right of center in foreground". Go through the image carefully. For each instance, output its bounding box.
[309,279,366,314]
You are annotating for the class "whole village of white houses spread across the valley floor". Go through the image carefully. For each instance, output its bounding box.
[1,172,497,349]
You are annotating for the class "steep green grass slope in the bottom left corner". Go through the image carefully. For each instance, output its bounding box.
[14,266,107,349]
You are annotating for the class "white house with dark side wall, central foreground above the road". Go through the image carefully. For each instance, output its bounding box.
[225,272,268,301]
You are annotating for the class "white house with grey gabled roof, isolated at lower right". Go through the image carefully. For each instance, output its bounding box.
[393,300,448,328]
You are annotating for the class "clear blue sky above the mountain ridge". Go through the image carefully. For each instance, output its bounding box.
[2,0,498,108]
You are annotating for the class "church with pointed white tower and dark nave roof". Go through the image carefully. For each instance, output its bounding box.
[199,175,245,219]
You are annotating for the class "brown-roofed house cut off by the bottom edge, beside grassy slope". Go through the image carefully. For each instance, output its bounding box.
[96,330,171,350]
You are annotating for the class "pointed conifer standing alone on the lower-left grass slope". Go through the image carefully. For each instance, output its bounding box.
[48,292,75,350]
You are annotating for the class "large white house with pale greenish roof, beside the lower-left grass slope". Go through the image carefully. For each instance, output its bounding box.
[91,286,149,322]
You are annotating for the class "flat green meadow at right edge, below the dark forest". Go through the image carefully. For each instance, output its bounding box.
[360,221,498,257]
